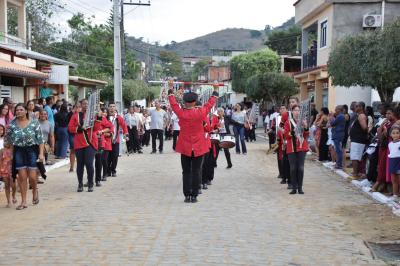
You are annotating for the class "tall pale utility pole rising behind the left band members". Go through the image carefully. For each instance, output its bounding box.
[113,0,123,114]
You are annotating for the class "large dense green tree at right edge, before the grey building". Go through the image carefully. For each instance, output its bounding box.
[328,19,400,102]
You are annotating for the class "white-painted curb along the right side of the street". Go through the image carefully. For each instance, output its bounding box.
[322,162,400,217]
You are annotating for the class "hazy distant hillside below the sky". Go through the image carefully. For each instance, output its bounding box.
[127,18,294,60]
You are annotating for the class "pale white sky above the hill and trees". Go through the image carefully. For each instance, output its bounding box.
[57,0,295,44]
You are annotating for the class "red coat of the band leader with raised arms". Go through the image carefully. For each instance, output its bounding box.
[168,95,217,157]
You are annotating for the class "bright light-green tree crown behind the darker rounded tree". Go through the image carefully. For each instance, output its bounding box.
[230,48,281,93]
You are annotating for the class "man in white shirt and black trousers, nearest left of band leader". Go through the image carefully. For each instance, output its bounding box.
[150,101,167,154]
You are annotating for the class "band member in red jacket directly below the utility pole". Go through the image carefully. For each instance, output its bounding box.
[108,103,129,177]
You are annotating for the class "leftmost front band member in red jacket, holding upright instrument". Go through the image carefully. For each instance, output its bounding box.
[68,99,102,192]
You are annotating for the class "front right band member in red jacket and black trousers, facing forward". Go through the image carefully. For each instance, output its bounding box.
[284,105,309,194]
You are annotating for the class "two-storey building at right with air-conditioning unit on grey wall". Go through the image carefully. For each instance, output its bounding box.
[294,0,400,110]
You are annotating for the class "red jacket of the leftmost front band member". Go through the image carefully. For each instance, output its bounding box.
[68,113,105,150]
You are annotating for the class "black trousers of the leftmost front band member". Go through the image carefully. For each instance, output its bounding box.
[75,146,96,187]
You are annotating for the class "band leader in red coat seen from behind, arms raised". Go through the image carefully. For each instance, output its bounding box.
[168,86,218,203]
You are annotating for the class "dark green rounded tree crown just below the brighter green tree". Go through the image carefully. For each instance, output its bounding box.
[246,72,298,105]
